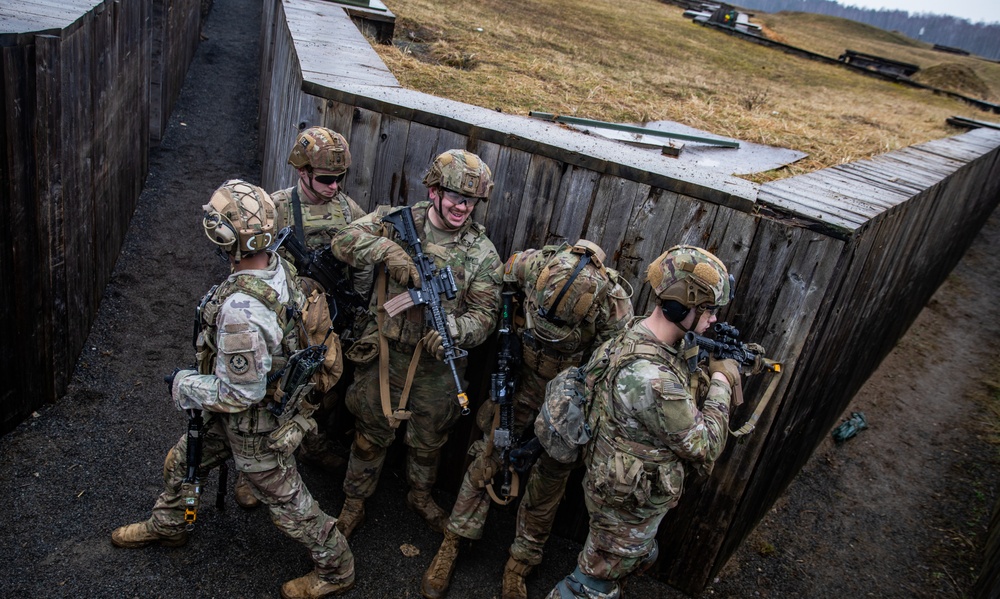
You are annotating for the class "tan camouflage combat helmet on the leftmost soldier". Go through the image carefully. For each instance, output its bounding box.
[202,179,275,262]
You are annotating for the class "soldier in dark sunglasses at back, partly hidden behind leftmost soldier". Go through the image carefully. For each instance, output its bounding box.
[229,127,372,509]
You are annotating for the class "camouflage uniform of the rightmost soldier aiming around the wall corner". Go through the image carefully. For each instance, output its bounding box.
[552,321,730,597]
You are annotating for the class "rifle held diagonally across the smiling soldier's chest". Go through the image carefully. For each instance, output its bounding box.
[382,206,469,415]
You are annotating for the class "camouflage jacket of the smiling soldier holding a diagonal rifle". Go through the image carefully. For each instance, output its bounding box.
[331,202,502,349]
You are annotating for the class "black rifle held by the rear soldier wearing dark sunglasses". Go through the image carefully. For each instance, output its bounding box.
[268,227,368,339]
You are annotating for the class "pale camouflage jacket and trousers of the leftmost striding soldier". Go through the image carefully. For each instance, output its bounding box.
[150,256,354,581]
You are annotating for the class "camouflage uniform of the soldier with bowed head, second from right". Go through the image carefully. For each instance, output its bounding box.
[448,245,632,565]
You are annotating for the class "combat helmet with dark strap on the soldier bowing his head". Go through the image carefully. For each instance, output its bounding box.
[534,239,611,327]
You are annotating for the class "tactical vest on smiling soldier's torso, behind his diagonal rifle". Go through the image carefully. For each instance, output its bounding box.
[369,202,486,347]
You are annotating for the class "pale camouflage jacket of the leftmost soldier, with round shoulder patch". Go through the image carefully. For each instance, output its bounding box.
[177,255,303,432]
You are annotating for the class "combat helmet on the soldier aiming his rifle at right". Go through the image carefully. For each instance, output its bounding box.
[646,245,735,323]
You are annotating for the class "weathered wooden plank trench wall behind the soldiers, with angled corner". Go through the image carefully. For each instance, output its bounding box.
[260,0,1000,592]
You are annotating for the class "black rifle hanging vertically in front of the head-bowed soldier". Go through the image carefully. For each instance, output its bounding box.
[486,291,521,505]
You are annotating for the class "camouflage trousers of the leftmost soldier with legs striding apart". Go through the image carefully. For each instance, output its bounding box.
[150,416,354,582]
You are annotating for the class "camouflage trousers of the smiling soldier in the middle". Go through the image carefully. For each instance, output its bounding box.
[344,342,465,498]
